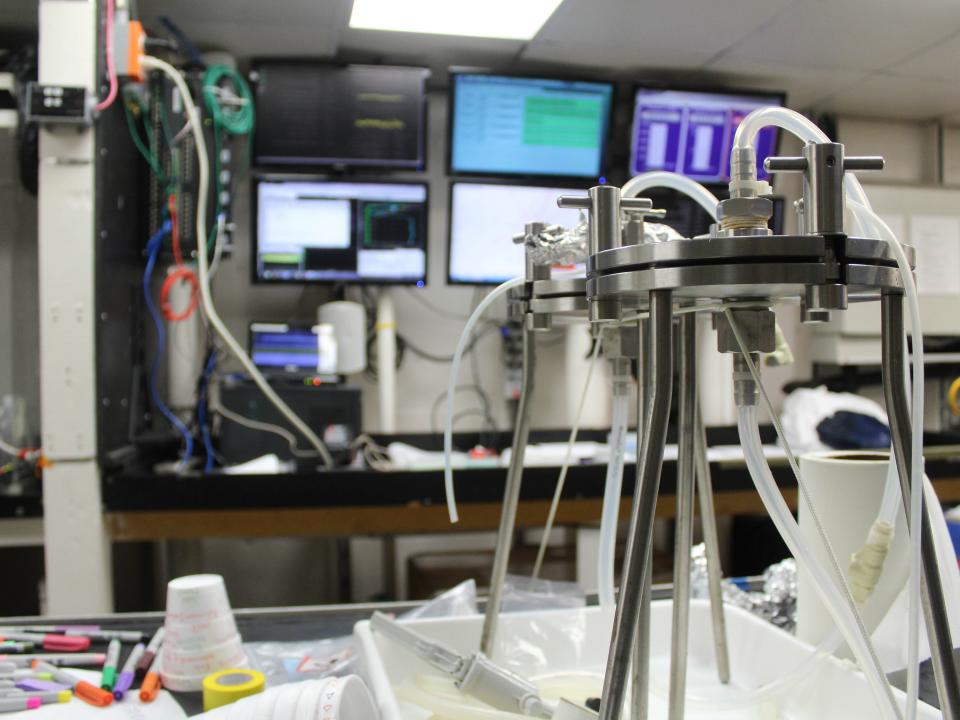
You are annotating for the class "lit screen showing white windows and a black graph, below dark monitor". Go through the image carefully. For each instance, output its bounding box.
[253,177,427,284]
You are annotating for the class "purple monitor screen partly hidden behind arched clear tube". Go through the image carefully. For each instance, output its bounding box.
[630,87,784,183]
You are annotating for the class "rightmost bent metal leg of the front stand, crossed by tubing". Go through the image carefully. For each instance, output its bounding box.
[880,293,960,720]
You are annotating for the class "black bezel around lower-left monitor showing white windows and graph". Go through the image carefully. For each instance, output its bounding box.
[250,172,430,287]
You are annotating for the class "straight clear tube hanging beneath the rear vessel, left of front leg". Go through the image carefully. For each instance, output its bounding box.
[597,382,630,608]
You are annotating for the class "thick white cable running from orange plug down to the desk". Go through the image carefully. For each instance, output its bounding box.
[140,55,333,467]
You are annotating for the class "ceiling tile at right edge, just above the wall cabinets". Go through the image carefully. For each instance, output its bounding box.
[817,73,960,120]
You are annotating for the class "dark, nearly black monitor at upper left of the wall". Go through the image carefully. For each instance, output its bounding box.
[253,60,429,170]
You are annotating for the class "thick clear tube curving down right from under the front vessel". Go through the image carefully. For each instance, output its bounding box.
[737,406,900,718]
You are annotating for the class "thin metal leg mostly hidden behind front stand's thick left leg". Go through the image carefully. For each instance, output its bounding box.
[630,320,653,719]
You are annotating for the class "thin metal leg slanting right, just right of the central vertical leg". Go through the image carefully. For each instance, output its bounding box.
[696,393,730,685]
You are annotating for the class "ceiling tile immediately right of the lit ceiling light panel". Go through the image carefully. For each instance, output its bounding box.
[523,0,790,70]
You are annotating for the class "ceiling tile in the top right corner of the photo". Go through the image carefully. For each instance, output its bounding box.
[715,0,960,70]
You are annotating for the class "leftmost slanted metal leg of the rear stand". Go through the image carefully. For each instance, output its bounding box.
[480,325,536,656]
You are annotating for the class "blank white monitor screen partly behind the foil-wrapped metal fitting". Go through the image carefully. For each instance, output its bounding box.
[447,182,586,285]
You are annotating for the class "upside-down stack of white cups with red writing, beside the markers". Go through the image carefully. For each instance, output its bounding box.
[160,575,247,692]
